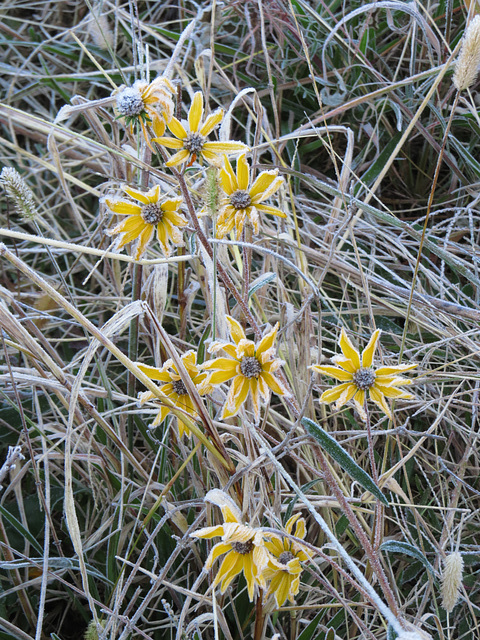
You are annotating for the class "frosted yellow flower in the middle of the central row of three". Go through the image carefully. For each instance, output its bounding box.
[201,316,287,422]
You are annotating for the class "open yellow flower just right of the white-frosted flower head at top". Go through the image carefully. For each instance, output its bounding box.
[154,91,248,167]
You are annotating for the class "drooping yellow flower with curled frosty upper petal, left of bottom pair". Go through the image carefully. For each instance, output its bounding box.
[191,490,268,602]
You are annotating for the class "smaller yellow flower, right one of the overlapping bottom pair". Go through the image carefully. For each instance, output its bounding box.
[263,514,310,607]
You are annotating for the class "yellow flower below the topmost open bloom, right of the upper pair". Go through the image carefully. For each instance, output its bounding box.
[217,154,287,238]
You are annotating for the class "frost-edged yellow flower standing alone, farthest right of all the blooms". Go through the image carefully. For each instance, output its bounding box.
[311,328,417,420]
